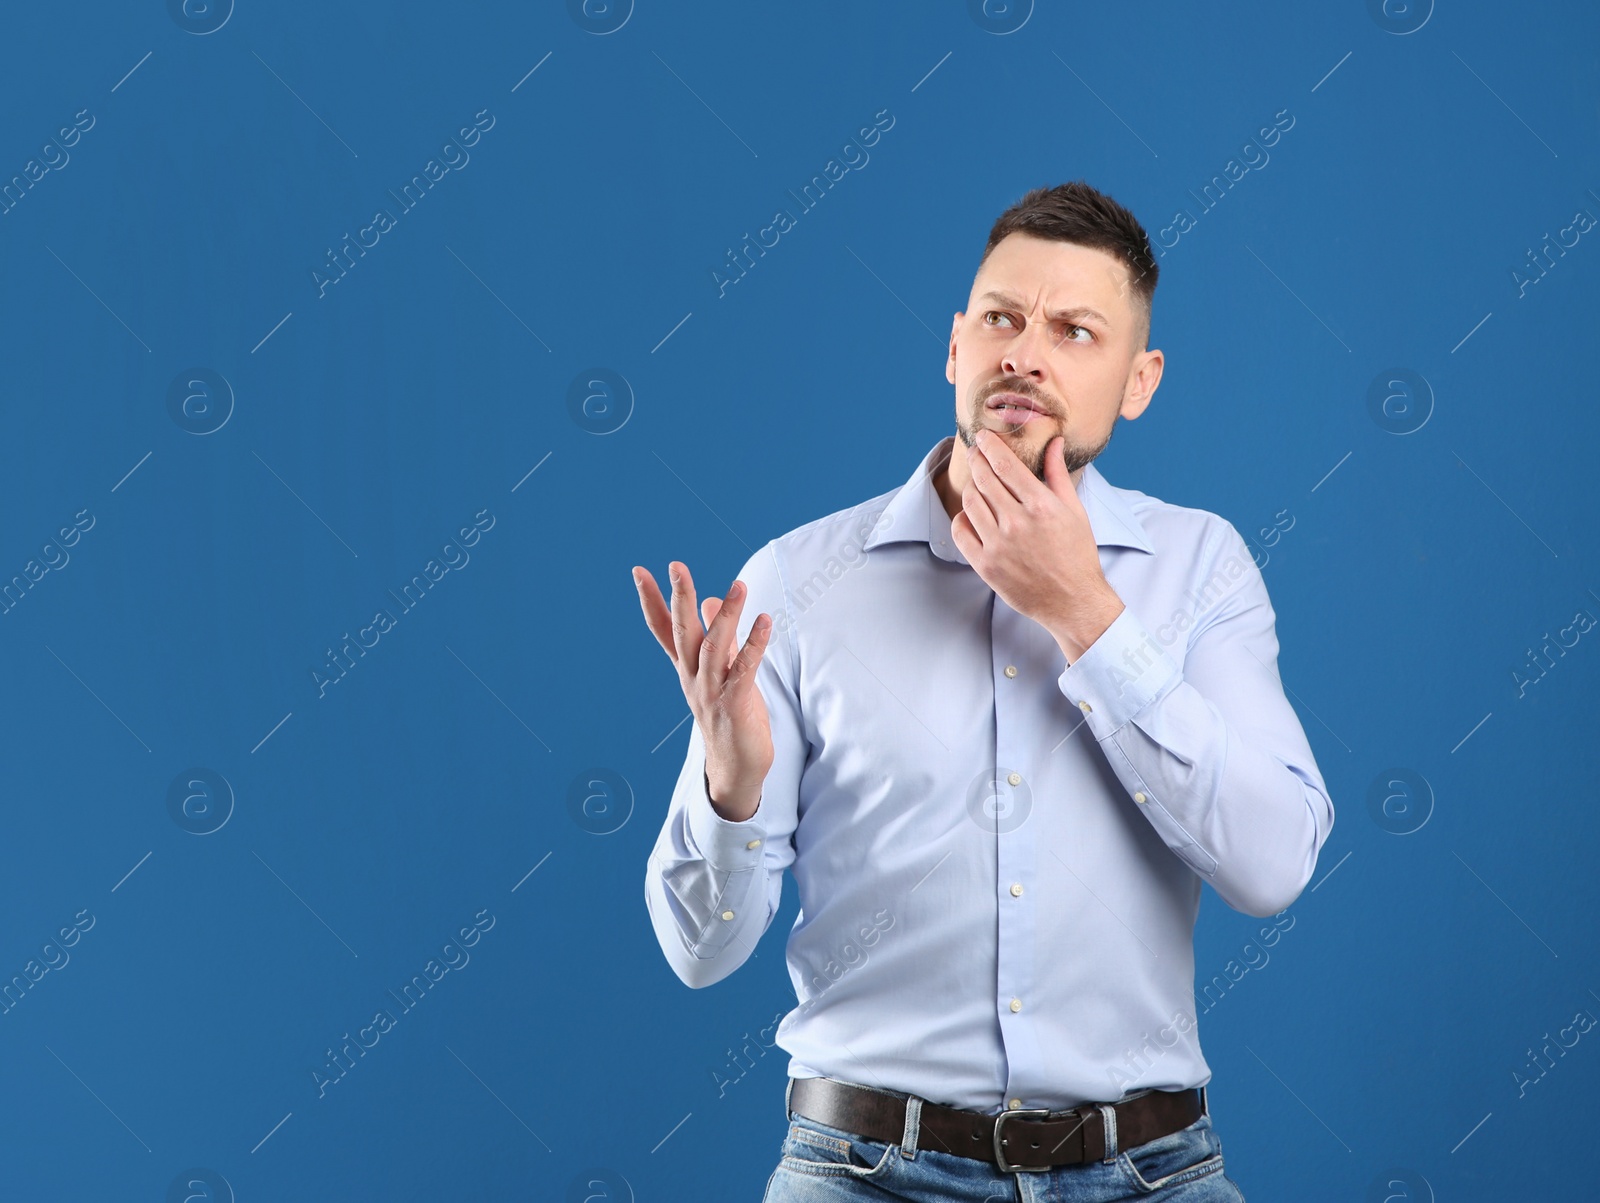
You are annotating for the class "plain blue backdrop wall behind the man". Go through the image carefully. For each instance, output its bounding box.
[0,0,1600,1203]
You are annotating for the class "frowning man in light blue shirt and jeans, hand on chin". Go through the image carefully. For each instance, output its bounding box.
[634,182,1333,1203]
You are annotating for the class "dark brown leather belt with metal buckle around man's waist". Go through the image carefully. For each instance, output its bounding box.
[786,1078,1205,1173]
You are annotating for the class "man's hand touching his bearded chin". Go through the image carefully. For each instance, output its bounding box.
[950,429,1123,664]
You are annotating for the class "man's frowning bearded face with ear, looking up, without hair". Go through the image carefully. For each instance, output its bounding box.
[944,234,1162,485]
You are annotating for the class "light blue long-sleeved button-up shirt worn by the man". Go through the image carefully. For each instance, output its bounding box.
[645,435,1333,1113]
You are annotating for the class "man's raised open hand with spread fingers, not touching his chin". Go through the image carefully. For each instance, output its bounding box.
[634,560,773,822]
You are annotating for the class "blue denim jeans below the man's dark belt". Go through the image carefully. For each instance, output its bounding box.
[762,1087,1245,1203]
